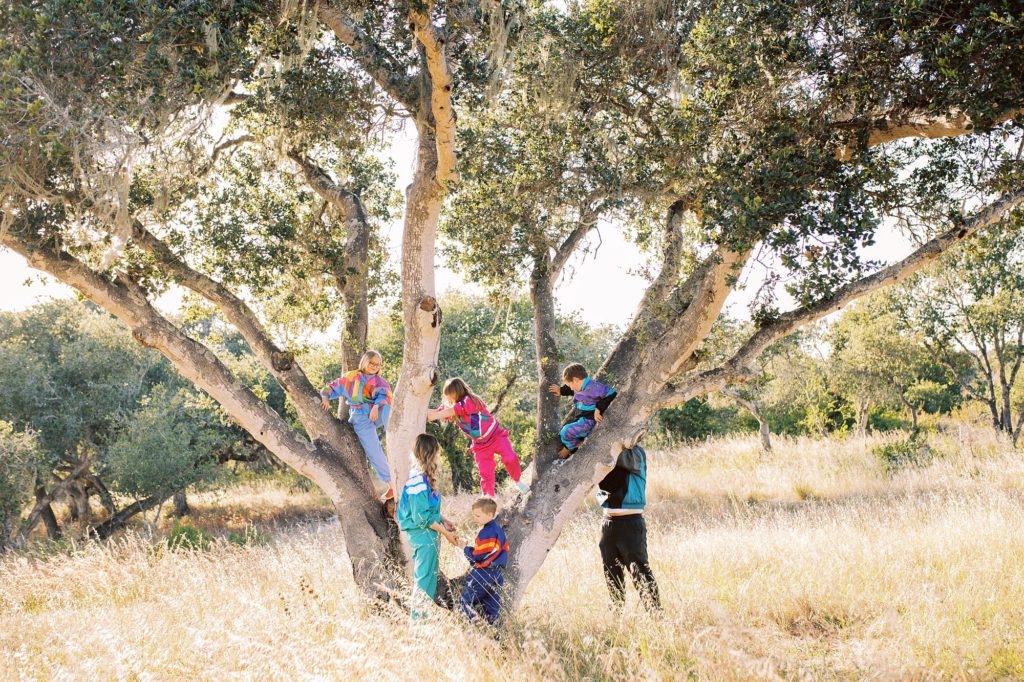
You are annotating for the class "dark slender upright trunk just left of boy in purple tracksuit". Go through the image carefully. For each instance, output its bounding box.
[529,249,562,478]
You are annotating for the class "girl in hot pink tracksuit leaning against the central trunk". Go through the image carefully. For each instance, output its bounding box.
[427,377,529,497]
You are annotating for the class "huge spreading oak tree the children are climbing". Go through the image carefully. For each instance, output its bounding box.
[0,0,1024,596]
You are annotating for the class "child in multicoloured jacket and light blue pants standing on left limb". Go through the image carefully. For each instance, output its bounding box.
[321,350,394,501]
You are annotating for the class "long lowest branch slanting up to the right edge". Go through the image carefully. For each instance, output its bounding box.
[657,189,1024,408]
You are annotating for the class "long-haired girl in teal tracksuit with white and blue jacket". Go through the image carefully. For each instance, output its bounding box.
[397,433,459,617]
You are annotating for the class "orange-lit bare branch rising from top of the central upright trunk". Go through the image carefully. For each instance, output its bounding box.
[409,8,459,195]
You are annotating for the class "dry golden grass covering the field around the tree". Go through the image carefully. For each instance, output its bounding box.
[0,427,1024,680]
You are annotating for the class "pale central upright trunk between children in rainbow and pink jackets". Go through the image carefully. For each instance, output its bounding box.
[387,124,444,489]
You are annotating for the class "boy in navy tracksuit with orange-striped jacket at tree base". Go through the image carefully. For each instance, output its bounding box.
[459,498,509,625]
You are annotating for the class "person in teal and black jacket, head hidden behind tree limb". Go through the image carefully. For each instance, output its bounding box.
[597,445,662,610]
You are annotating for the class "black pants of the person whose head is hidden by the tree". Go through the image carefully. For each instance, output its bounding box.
[600,514,662,609]
